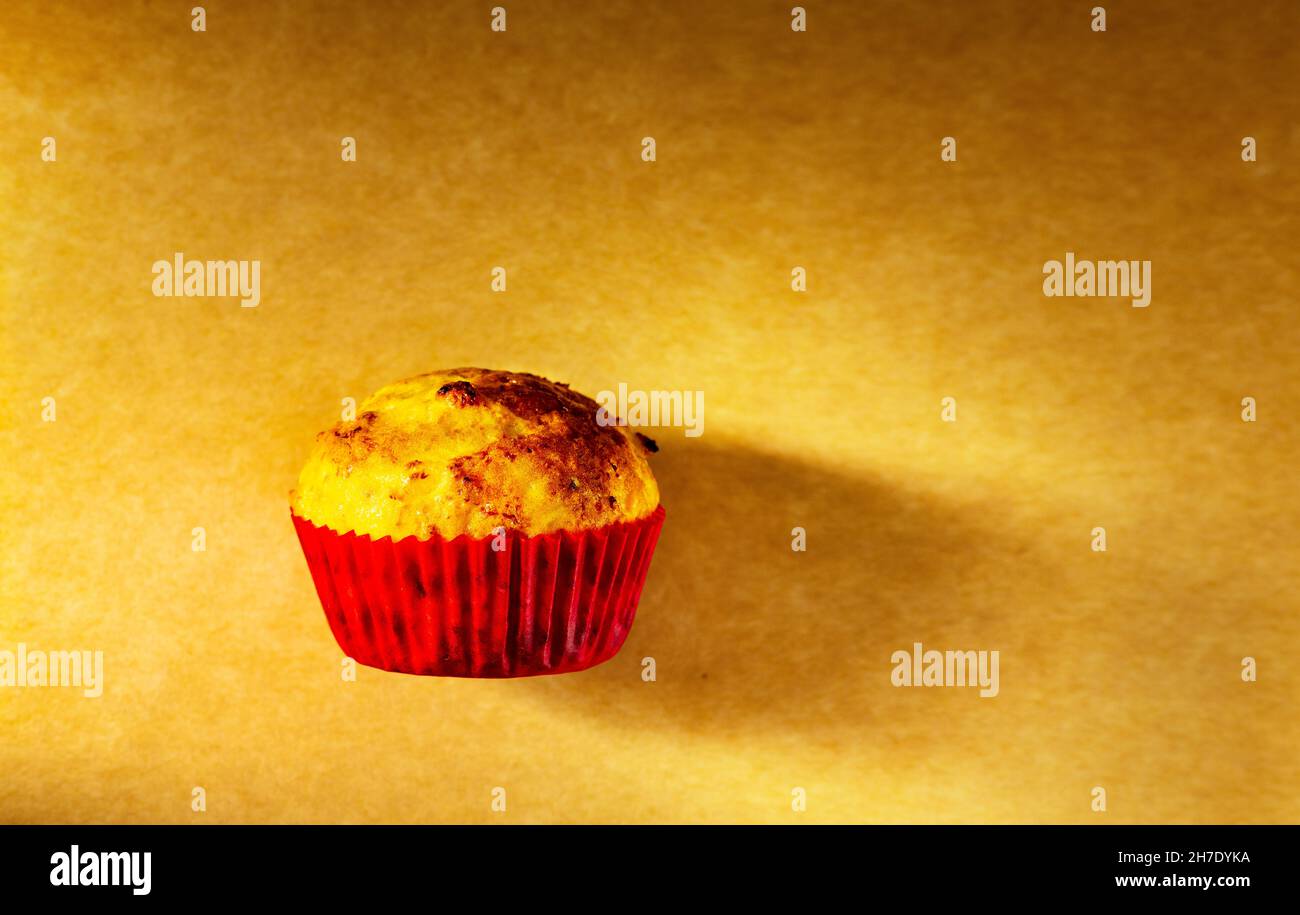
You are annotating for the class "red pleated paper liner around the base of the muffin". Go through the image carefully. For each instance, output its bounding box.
[290,506,664,677]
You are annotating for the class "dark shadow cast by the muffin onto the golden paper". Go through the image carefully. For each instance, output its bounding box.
[525,433,1049,737]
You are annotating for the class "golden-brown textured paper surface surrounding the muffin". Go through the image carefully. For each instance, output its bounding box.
[0,0,1300,823]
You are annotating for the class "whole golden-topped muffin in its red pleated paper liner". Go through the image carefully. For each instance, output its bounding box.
[290,368,664,677]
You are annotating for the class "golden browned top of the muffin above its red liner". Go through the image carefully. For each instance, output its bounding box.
[291,368,659,541]
